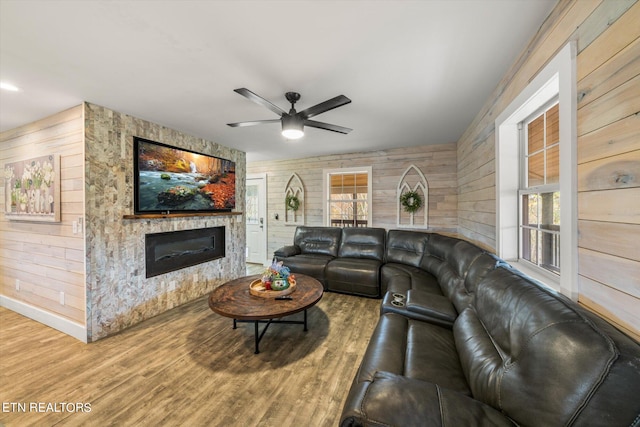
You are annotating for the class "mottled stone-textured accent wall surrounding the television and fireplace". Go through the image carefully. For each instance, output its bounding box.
[84,103,246,341]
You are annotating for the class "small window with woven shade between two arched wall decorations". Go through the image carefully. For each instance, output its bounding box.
[324,167,371,227]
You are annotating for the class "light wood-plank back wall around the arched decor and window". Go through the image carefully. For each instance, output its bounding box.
[247,143,457,257]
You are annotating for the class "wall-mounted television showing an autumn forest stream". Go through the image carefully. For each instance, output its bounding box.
[133,137,236,214]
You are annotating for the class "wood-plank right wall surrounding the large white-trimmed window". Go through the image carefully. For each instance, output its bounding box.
[458,0,640,338]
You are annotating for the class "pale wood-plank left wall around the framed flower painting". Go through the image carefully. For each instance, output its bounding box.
[0,106,85,326]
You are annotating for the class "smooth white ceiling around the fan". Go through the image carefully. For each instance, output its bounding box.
[0,0,556,161]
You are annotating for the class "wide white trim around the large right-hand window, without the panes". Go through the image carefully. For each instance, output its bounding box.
[495,41,578,300]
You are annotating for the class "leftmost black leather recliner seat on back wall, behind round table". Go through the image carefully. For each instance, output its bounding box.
[274,226,342,290]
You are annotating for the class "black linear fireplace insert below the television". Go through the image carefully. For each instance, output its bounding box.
[145,226,225,277]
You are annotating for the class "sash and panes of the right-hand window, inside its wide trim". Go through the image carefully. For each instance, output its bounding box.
[519,100,560,274]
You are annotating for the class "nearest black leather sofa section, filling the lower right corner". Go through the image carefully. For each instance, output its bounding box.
[341,265,640,427]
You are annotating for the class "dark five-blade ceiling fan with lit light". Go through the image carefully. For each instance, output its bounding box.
[227,88,352,139]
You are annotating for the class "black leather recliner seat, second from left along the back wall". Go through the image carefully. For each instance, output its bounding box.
[325,227,386,298]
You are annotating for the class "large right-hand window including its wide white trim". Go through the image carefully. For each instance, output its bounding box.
[495,42,578,300]
